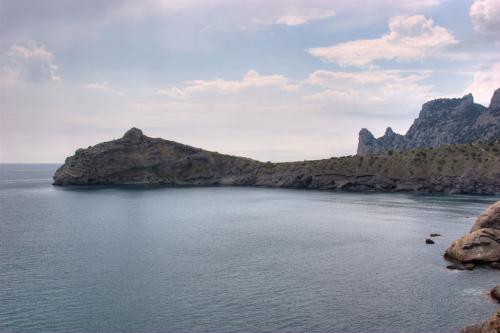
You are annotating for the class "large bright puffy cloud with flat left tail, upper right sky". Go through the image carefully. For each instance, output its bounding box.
[308,15,458,67]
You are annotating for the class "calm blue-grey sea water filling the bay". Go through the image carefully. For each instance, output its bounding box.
[0,165,500,333]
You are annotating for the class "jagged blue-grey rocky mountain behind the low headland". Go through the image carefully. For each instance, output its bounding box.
[358,89,500,155]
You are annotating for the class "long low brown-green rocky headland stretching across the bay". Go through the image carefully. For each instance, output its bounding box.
[54,128,500,194]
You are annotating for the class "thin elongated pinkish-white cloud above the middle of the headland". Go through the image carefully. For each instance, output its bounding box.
[156,70,298,99]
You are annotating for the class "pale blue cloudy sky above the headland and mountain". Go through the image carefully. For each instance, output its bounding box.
[0,0,500,163]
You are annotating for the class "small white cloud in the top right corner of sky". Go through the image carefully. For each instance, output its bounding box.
[469,0,500,35]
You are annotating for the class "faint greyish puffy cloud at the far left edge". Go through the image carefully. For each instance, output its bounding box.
[2,41,60,84]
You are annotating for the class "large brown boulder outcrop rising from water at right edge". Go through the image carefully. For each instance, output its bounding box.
[445,201,500,264]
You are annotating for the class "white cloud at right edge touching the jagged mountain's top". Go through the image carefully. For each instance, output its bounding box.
[464,62,500,105]
